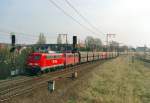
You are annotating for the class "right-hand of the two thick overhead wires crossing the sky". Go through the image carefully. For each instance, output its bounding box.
[65,0,105,35]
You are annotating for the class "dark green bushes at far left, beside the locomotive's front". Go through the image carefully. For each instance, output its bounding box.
[0,48,32,79]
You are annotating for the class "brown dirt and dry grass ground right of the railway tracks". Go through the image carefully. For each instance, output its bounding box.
[5,56,150,103]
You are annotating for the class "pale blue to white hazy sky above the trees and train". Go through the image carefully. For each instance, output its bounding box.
[0,0,150,47]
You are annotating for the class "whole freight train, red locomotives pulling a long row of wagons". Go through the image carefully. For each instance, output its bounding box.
[26,52,118,74]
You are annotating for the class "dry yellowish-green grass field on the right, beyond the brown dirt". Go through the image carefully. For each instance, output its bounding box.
[68,57,150,103]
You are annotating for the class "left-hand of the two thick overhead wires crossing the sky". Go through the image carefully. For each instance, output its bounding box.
[49,0,99,35]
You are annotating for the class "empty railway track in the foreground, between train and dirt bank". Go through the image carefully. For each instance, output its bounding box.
[0,60,113,102]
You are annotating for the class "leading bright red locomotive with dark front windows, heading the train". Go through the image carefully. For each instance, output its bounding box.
[27,53,64,73]
